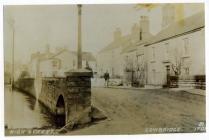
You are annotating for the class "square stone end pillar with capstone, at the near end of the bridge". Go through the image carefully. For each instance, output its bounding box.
[65,70,92,124]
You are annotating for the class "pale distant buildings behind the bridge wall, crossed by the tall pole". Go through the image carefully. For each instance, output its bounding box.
[29,48,96,77]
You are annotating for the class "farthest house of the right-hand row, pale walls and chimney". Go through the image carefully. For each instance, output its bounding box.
[97,28,131,78]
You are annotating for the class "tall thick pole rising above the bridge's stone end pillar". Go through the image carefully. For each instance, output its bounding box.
[77,4,82,69]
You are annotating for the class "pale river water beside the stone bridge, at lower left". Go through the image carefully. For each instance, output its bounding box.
[4,86,56,129]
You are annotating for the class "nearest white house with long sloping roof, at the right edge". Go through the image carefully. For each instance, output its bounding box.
[145,12,205,86]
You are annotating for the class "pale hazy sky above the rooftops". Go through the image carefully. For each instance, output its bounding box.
[3,4,202,63]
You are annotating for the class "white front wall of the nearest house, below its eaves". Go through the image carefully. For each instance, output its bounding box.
[145,29,205,85]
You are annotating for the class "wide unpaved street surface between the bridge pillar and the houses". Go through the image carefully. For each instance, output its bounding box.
[68,88,205,135]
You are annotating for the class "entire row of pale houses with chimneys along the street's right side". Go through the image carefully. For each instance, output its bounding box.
[97,5,205,86]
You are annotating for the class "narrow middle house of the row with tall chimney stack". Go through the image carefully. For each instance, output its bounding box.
[121,16,153,86]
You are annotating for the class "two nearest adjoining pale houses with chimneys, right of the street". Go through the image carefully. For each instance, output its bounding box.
[116,4,205,88]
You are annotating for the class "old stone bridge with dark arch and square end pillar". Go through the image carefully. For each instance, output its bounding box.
[16,70,92,127]
